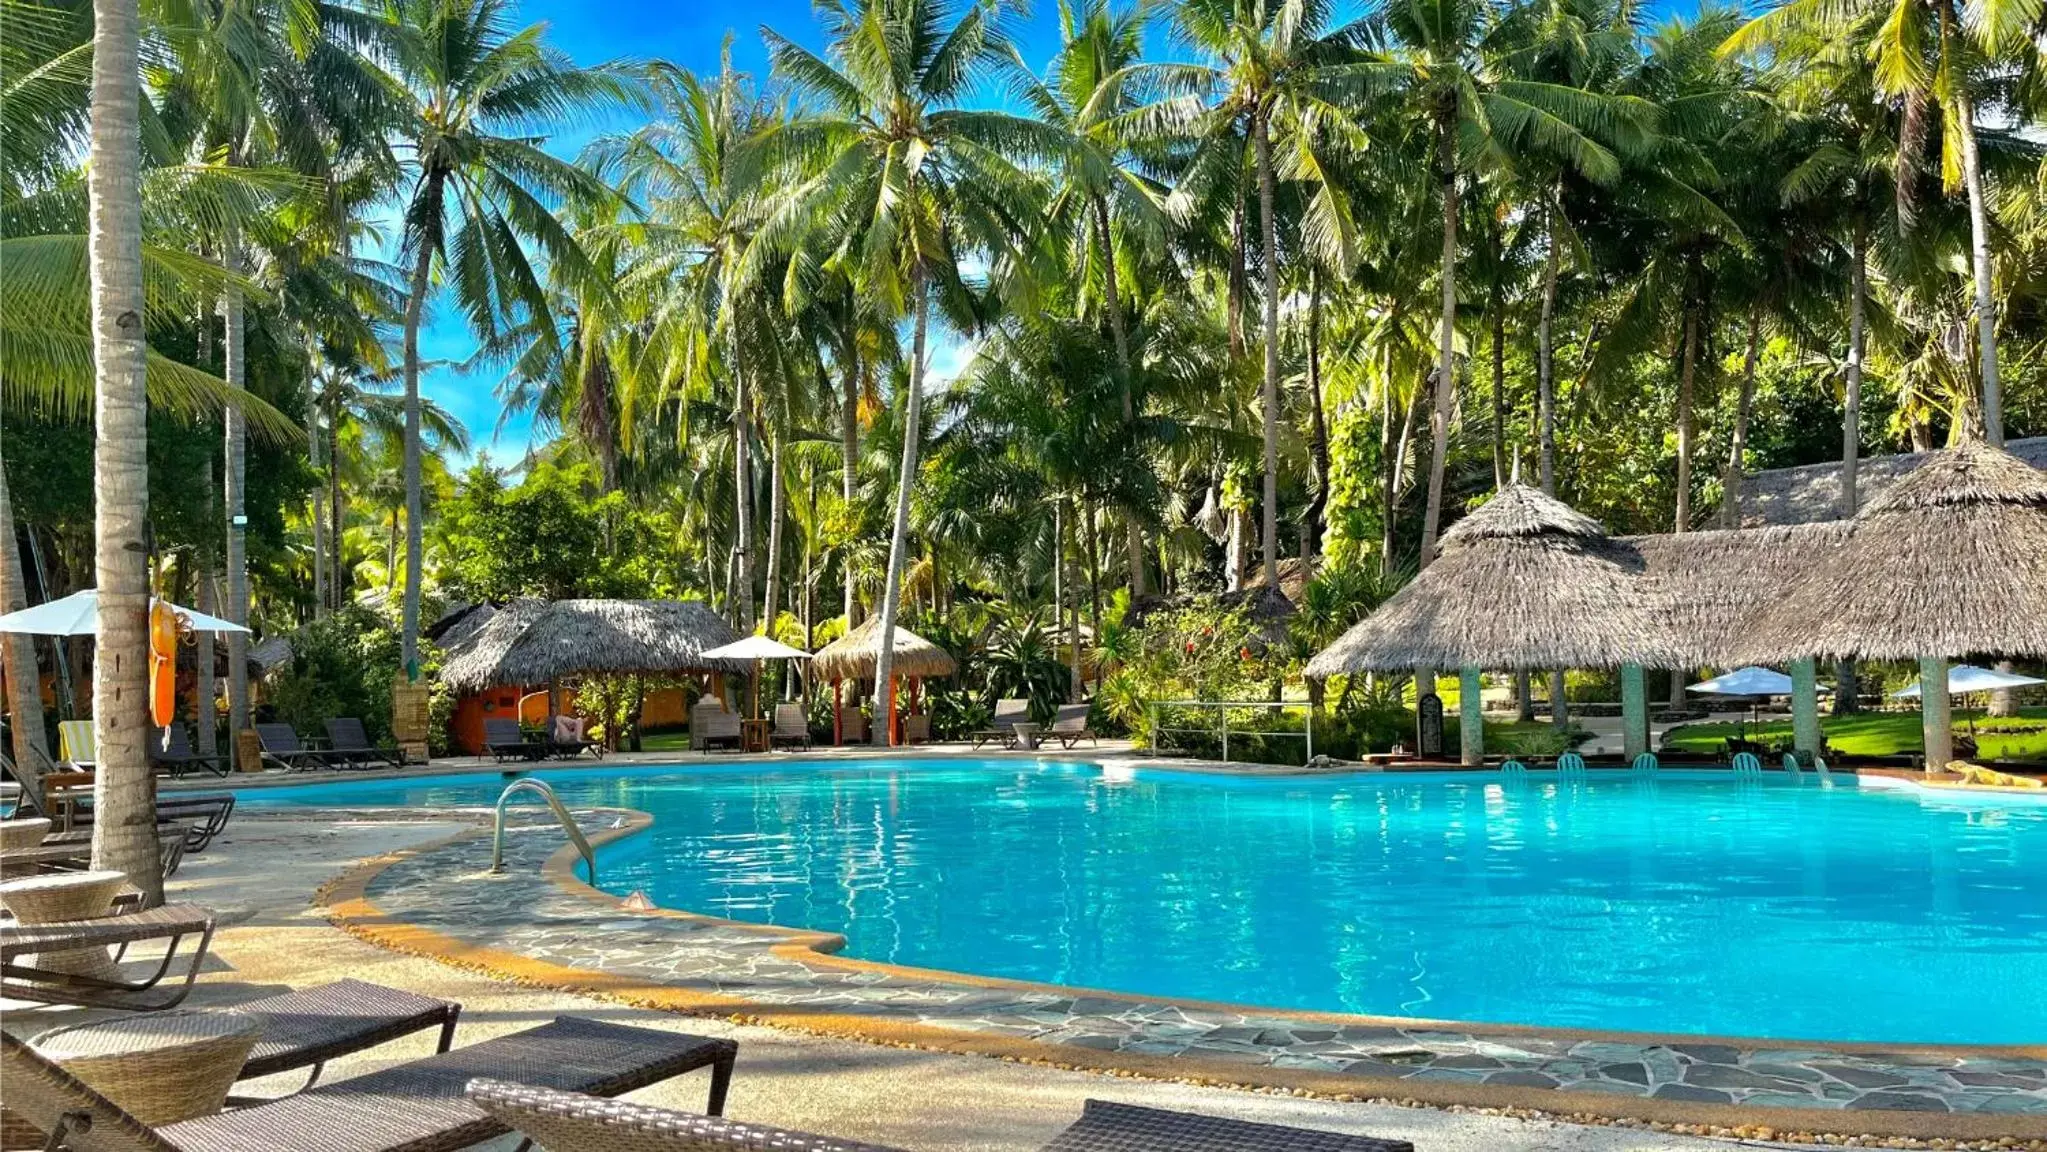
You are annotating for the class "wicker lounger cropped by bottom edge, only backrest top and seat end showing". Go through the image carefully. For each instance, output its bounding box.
[469,1080,1414,1152]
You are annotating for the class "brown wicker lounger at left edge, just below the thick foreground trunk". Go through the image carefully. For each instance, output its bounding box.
[0,904,213,1011]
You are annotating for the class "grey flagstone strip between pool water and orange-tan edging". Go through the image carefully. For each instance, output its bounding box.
[339,812,2047,1127]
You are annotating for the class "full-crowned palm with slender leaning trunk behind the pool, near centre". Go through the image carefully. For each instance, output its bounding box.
[755,0,1062,741]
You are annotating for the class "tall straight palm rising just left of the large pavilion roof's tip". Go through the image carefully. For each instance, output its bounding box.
[1144,0,1371,589]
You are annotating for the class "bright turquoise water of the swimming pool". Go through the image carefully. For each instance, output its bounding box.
[244,761,2047,1044]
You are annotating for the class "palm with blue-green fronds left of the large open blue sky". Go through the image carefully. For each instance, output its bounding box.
[364,0,633,679]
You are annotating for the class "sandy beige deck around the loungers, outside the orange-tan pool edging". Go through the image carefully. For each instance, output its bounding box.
[4,814,1809,1152]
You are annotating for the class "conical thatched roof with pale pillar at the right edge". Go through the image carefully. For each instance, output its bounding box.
[1742,444,2047,771]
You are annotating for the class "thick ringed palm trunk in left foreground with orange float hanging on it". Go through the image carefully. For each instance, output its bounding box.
[86,0,164,906]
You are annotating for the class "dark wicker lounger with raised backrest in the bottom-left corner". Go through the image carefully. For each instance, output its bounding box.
[0,1017,739,1152]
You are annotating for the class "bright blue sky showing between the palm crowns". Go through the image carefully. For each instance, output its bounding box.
[420,0,1695,464]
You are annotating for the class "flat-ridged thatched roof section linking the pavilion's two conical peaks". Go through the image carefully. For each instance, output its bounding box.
[1615,520,1848,667]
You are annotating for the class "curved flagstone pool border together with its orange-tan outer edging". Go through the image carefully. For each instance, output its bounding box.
[315,808,2047,1142]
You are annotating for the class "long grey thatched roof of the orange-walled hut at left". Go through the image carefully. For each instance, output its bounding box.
[440,600,751,692]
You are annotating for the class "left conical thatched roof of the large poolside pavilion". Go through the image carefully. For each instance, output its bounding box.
[1308,485,1685,677]
